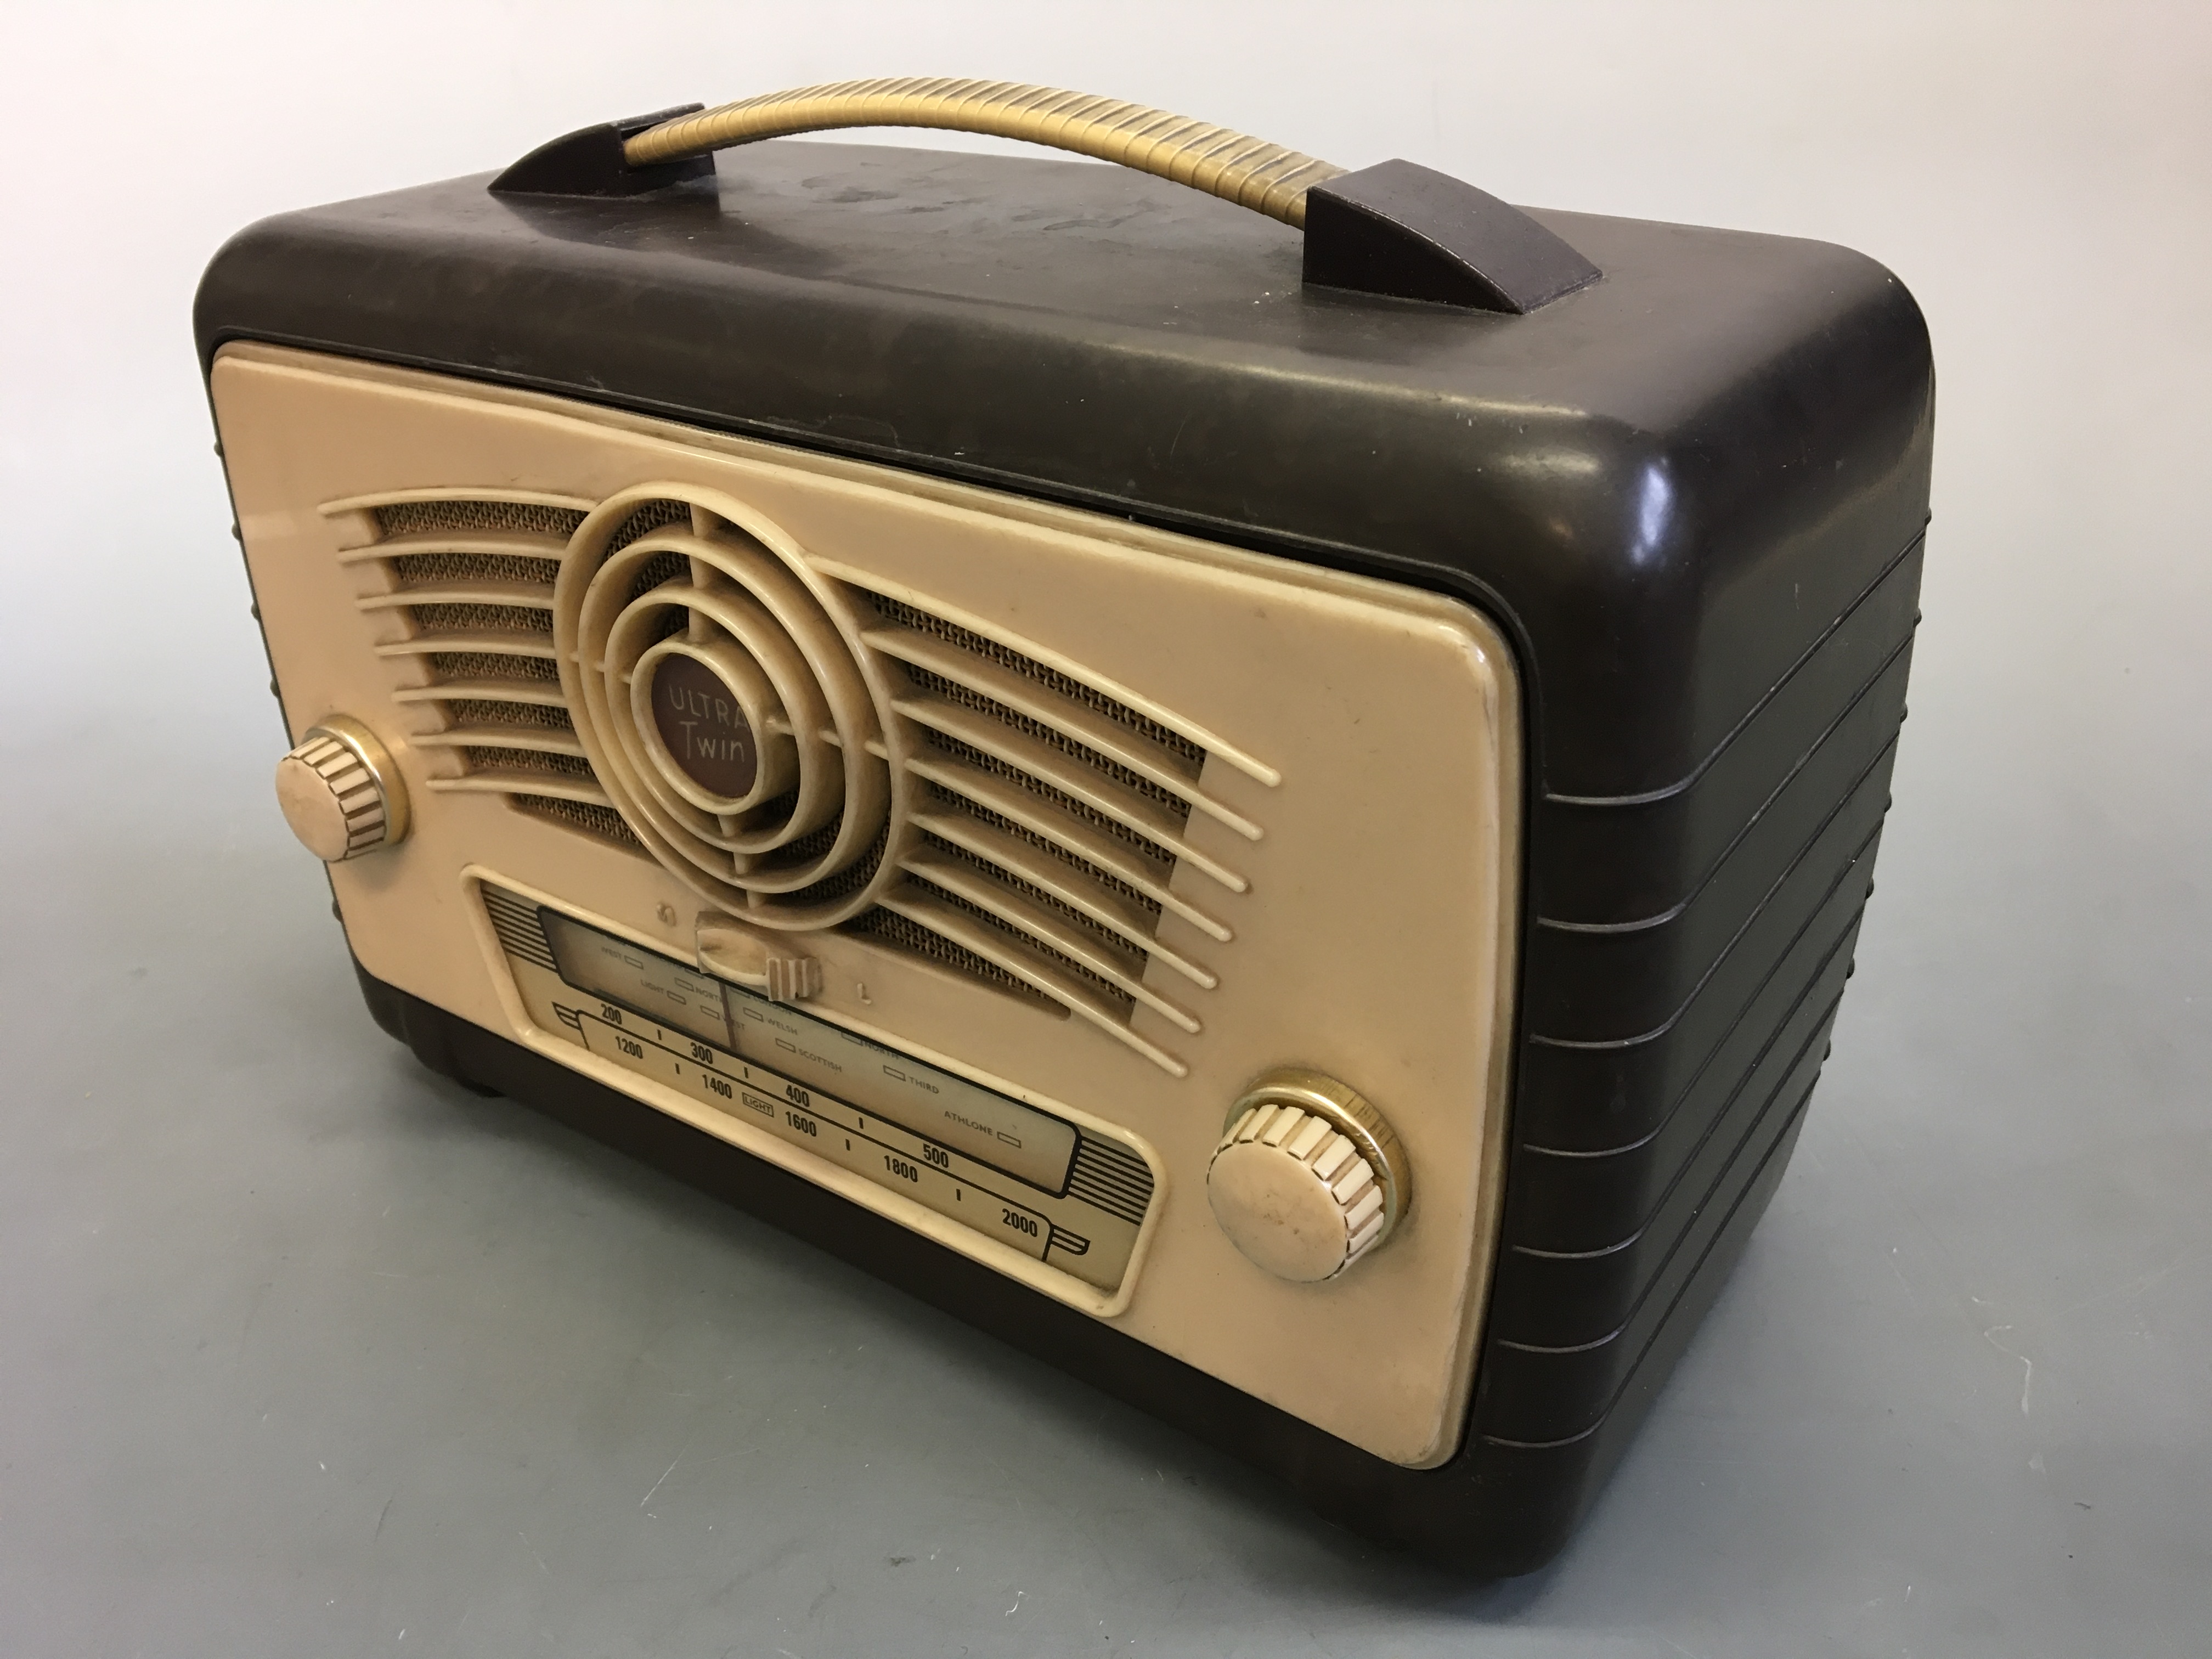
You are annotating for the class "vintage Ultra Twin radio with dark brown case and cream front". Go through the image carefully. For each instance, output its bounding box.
[197,82,1933,1573]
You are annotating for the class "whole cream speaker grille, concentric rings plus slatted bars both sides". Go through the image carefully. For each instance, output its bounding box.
[325,484,1259,1075]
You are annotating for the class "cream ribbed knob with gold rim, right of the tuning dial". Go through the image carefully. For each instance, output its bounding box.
[1205,1066,1411,1285]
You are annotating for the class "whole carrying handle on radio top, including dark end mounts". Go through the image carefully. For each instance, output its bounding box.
[491,77,1599,312]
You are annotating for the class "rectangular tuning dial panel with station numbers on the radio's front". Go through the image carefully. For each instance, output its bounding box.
[482,885,1153,1290]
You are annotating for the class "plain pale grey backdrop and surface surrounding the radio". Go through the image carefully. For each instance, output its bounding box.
[0,2,2212,1659]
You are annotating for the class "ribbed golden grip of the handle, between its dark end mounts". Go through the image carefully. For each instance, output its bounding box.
[622,77,1345,225]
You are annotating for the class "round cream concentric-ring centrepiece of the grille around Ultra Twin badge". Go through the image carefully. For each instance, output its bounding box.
[553,487,911,929]
